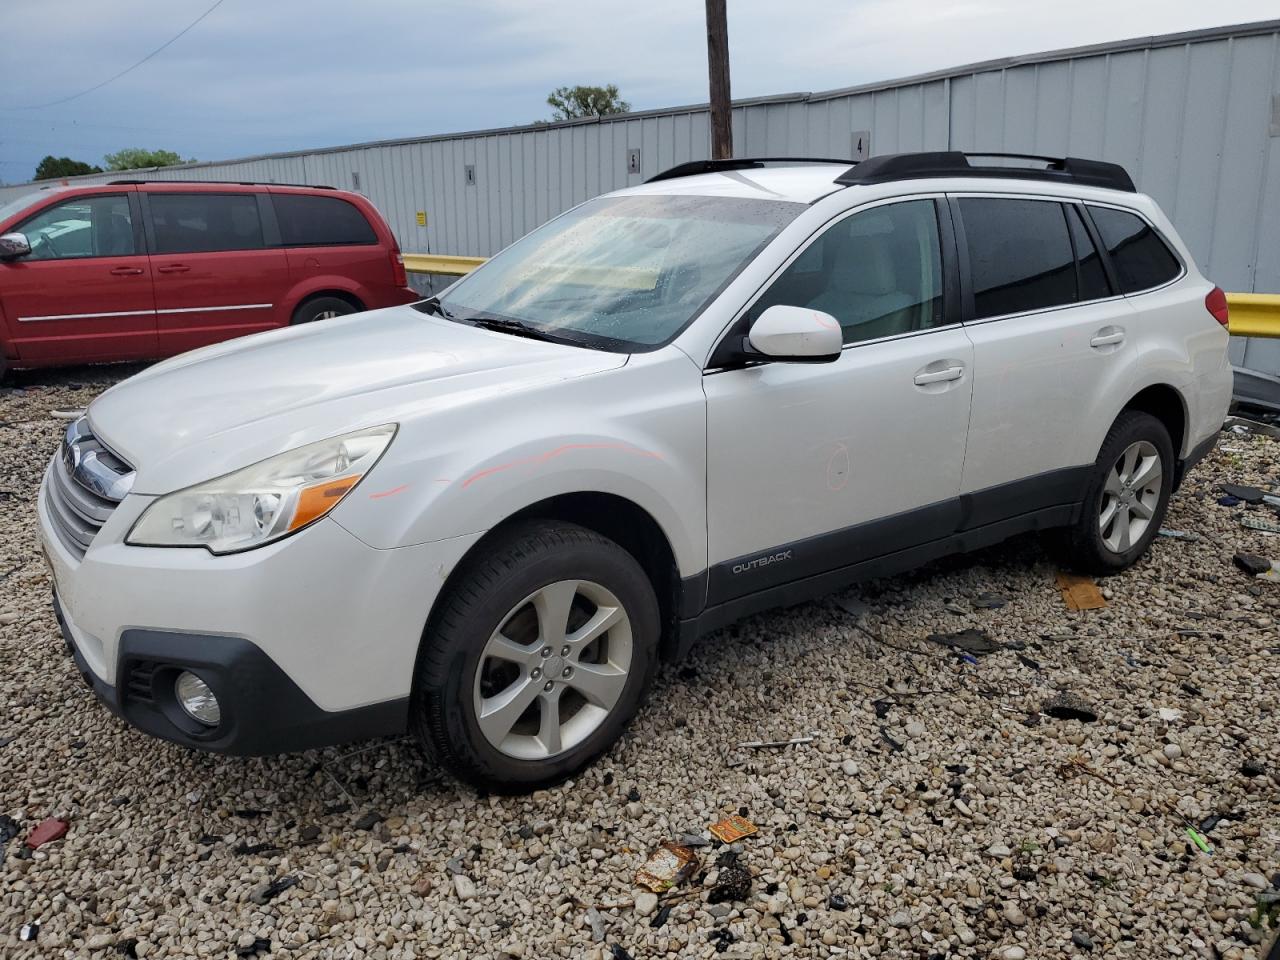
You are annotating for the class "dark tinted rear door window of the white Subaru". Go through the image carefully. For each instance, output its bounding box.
[960,197,1076,320]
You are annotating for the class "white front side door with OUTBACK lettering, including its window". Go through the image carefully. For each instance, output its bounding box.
[703,198,973,605]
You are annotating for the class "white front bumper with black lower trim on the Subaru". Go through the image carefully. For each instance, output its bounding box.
[38,463,480,754]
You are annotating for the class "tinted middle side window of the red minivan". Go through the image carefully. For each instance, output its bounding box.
[147,193,266,253]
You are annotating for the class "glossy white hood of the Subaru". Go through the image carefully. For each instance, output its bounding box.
[88,306,627,494]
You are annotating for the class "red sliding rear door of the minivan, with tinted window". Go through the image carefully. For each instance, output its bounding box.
[140,184,289,356]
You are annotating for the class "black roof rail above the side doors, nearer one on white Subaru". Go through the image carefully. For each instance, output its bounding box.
[836,150,1138,193]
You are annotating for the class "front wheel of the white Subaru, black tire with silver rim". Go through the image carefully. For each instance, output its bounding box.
[410,521,660,794]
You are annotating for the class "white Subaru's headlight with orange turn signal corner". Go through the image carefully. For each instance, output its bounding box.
[125,424,396,553]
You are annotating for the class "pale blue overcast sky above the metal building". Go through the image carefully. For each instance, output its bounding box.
[0,0,1280,183]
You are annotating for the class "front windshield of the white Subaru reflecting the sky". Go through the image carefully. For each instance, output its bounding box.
[439,195,804,351]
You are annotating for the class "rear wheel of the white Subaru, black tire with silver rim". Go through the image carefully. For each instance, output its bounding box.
[1050,410,1175,576]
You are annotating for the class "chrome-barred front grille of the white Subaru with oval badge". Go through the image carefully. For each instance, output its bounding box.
[45,417,133,557]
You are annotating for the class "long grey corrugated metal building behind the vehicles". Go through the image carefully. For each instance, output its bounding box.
[0,20,1280,374]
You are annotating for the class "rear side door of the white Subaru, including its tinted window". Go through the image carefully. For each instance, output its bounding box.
[951,195,1134,514]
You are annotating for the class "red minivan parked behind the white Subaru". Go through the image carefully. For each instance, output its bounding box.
[0,180,421,374]
